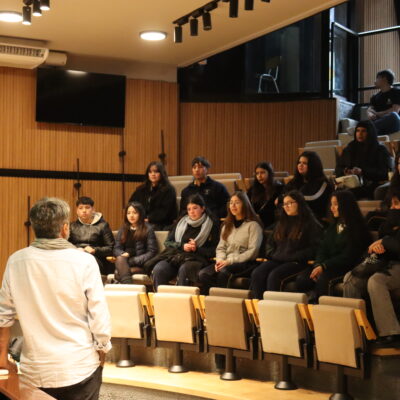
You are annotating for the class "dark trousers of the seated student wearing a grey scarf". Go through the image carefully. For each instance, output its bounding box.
[153,260,203,290]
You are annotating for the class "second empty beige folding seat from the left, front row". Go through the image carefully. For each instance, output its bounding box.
[153,285,203,373]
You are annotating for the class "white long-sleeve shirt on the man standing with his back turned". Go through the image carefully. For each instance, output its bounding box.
[0,246,111,388]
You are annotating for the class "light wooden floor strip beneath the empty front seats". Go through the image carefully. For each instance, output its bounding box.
[103,364,330,400]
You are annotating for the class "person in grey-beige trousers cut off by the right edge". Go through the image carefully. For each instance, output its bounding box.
[343,191,400,347]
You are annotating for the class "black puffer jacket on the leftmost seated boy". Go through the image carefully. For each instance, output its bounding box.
[68,212,115,258]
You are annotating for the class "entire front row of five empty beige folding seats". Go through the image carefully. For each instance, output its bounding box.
[105,285,376,399]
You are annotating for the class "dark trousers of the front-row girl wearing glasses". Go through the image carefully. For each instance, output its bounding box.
[250,261,305,300]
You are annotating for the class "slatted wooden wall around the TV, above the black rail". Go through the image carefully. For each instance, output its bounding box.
[0,67,178,174]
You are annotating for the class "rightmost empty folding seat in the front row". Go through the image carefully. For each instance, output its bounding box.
[309,296,376,399]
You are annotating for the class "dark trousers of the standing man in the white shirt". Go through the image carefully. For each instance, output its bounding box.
[40,367,103,400]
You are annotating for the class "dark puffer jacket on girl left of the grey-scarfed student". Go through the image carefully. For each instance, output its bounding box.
[114,224,158,267]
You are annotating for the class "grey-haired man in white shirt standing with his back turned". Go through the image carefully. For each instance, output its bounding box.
[0,198,111,400]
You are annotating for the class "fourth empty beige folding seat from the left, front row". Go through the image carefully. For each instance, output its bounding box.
[258,292,312,390]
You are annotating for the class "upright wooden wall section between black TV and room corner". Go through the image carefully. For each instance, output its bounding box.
[125,80,178,175]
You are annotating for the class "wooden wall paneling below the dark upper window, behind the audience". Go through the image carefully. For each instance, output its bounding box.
[180,100,336,177]
